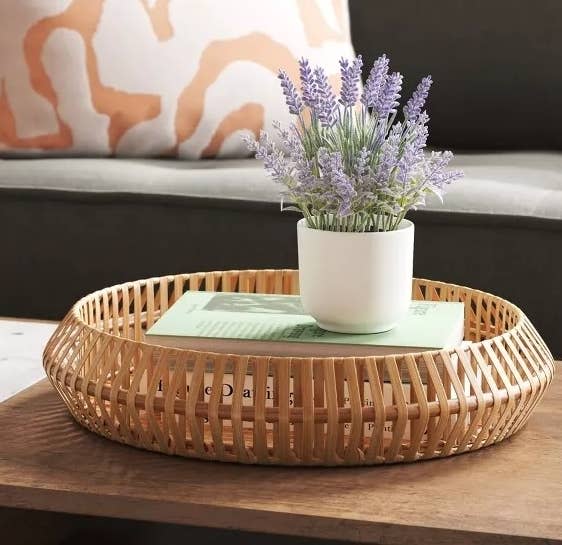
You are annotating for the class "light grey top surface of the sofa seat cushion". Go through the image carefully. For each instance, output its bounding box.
[0,152,562,219]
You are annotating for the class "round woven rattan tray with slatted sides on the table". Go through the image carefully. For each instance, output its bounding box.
[44,270,554,466]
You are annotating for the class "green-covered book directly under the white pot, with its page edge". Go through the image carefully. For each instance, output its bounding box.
[146,291,464,357]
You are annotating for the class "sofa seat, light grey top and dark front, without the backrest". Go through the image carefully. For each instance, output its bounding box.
[0,152,562,355]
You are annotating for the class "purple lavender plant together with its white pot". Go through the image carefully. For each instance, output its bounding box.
[248,55,462,333]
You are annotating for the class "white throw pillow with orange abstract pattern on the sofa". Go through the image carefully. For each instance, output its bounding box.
[0,0,353,159]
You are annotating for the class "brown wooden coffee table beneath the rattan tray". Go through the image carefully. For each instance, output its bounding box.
[0,316,562,544]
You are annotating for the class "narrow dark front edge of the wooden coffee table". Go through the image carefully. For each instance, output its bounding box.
[0,484,552,545]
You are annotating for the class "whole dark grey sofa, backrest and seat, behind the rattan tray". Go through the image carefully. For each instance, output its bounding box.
[0,0,562,355]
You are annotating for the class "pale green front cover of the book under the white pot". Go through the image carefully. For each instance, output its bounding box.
[147,291,464,348]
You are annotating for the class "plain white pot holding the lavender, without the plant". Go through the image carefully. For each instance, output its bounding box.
[297,219,414,333]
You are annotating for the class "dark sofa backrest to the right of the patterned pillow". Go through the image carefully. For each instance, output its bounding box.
[350,0,562,150]
